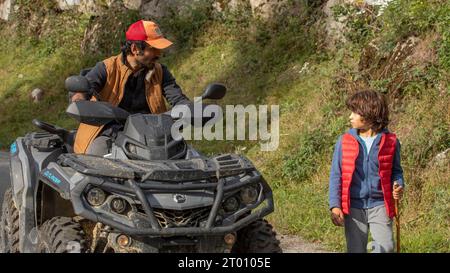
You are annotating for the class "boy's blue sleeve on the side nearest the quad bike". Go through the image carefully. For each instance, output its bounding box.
[329,137,342,209]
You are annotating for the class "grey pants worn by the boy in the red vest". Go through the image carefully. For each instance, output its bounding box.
[344,205,394,253]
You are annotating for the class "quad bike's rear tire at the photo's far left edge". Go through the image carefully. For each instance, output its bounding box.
[0,187,20,253]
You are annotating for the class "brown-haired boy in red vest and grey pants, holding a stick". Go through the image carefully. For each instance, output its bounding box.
[329,90,404,253]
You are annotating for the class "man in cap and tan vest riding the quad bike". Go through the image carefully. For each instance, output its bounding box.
[70,20,190,156]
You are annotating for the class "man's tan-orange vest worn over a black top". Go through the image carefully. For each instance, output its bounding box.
[74,54,167,154]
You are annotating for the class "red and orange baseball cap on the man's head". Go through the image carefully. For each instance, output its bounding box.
[125,20,172,49]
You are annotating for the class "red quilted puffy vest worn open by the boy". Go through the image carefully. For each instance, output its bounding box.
[341,133,397,218]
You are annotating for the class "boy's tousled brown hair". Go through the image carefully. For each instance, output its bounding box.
[345,90,389,132]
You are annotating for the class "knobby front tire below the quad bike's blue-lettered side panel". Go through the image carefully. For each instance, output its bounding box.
[38,217,86,253]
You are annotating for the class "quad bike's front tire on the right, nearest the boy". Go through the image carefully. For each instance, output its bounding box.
[232,219,282,253]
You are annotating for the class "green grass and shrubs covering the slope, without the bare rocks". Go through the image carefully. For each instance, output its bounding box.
[0,0,450,252]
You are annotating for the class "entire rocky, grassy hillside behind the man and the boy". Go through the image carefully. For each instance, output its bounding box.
[0,0,450,252]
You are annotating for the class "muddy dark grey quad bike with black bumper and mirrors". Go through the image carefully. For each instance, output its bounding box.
[0,73,281,253]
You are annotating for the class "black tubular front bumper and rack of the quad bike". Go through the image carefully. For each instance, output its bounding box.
[60,155,274,236]
